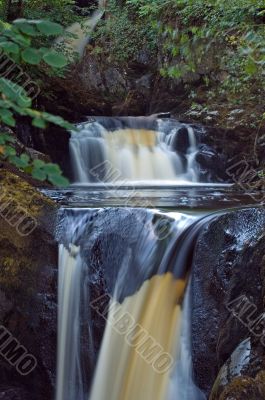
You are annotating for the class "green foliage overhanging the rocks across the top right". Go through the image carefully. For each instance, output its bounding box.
[95,0,265,95]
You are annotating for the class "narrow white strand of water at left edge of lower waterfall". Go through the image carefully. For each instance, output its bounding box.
[56,245,84,400]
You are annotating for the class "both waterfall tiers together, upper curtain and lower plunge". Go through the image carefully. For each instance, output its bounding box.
[56,117,236,400]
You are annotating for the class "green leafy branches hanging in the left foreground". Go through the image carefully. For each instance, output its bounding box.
[0,19,73,186]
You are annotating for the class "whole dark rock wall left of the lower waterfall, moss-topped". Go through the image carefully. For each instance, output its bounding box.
[0,171,57,400]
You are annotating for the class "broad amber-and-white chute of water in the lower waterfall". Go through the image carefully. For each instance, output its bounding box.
[89,273,185,400]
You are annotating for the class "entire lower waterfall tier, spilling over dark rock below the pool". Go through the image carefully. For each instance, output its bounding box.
[56,208,212,400]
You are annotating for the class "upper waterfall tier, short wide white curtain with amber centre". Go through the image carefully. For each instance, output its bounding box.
[70,117,198,184]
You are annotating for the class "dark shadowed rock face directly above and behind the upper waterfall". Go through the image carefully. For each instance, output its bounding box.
[50,42,186,116]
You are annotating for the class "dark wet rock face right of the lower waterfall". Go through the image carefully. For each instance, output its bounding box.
[192,209,265,399]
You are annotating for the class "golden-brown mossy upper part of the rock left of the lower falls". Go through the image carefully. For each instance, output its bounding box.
[0,170,57,294]
